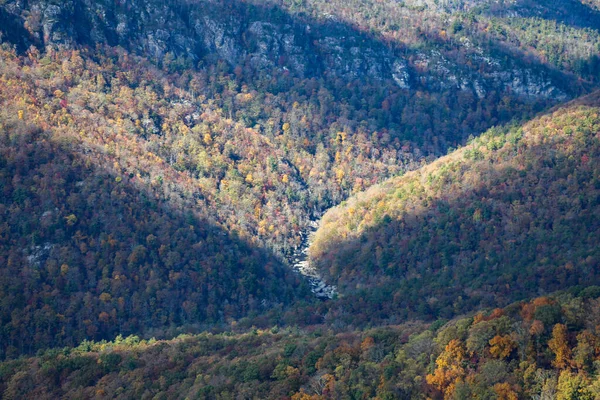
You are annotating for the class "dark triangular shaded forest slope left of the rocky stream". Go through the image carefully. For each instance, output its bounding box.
[0,120,308,357]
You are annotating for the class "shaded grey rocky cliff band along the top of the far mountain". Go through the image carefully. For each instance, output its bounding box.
[0,0,573,100]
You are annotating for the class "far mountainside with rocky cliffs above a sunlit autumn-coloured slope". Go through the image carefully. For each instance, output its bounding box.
[2,0,598,262]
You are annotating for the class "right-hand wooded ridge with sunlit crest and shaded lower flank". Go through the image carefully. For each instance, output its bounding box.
[310,93,600,323]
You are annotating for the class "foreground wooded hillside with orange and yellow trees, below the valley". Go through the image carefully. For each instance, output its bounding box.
[5,287,600,400]
